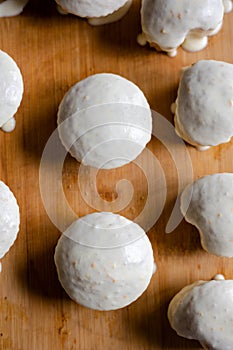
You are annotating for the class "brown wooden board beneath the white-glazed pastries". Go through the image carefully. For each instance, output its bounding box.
[0,0,233,350]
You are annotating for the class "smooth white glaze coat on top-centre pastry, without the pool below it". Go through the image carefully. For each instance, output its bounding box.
[55,0,128,18]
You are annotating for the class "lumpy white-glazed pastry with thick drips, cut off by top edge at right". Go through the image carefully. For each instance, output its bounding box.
[138,0,226,57]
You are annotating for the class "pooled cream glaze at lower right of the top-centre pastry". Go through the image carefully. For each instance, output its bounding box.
[88,0,132,26]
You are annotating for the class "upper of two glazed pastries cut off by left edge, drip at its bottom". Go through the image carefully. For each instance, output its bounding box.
[0,50,23,132]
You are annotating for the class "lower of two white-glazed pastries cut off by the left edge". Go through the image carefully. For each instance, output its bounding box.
[0,181,20,259]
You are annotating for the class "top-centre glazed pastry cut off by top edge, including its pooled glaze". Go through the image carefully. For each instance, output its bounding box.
[55,0,132,25]
